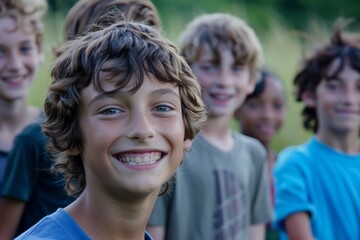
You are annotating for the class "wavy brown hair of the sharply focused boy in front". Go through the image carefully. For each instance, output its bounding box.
[42,19,206,195]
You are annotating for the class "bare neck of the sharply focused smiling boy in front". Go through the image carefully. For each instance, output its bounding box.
[65,192,157,240]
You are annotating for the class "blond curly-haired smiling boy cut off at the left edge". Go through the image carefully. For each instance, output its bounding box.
[0,0,47,183]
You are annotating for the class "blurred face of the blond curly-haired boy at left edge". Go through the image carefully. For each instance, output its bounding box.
[0,17,42,101]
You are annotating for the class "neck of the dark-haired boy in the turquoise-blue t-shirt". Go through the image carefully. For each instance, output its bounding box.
[316,132,360,154]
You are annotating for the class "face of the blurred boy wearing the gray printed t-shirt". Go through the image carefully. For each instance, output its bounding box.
[192,45,254,117]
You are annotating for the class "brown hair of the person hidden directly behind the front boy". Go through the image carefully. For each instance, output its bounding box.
[64,0,160,40]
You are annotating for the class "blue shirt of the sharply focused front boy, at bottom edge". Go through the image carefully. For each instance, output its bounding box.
[15,208,153,240]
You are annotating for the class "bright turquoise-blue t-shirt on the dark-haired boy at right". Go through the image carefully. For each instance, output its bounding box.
[274,137,360,240]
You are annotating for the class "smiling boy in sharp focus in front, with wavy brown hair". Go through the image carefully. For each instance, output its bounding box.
[18,19,206,240]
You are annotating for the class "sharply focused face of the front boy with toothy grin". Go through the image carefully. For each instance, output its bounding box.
[76,72,191,196]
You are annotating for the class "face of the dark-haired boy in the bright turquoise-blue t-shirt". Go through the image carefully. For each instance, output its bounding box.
[308,59,360,136]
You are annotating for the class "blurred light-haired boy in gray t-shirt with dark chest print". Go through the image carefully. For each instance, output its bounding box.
[147,14,272,240]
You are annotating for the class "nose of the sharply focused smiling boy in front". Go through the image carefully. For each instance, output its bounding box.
[127,113,155,141]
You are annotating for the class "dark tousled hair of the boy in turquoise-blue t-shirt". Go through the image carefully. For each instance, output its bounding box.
[294,20,360,133]
